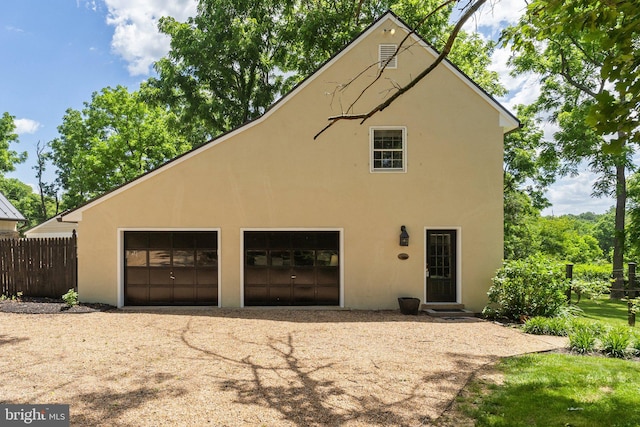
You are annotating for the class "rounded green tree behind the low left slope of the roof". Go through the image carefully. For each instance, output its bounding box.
[50,86,191,208]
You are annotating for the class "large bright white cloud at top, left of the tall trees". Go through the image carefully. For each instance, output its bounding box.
[105,0,197,76]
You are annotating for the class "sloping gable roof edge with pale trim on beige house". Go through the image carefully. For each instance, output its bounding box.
[60,11,520,222]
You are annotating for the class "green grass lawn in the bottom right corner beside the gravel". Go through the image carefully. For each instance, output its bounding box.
[458,354,640,427]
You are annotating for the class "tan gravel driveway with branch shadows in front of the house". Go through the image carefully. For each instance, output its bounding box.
[0,309,564,426]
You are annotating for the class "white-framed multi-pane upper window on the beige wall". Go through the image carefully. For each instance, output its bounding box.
[371,127,407,172]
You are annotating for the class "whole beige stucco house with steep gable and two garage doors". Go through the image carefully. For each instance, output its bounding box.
[62,13,519,311]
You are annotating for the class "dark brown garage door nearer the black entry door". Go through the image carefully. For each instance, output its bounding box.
[244,231,340,306]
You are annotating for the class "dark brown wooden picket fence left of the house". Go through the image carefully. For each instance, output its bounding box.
[0,232,78,298]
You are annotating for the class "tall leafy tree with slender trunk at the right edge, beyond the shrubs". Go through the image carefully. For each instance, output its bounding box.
[503,0,640,297]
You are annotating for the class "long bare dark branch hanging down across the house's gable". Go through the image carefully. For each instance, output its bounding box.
[313,0,487,140]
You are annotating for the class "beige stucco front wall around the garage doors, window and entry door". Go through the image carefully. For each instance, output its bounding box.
[71,16,503,311]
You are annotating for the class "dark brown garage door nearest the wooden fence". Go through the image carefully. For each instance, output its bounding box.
[124,231,218,305]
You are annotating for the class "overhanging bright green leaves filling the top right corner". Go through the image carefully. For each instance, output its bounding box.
[503,0,640,154]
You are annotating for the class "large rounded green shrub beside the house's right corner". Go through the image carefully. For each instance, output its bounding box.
[483,255,569,320]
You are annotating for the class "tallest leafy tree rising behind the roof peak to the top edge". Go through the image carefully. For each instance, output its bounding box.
[149,0,504,136]
